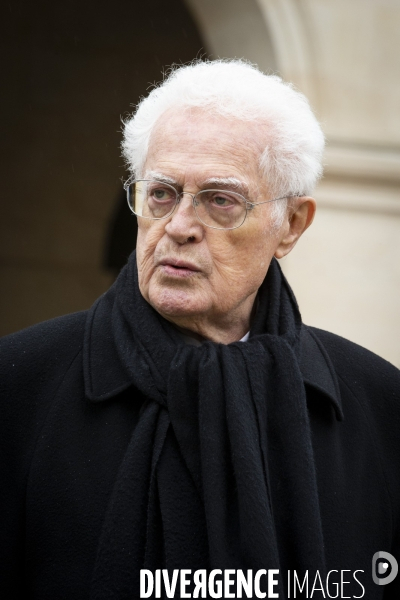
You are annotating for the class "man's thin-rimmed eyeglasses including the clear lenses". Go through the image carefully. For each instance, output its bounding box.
[124,179,288,229]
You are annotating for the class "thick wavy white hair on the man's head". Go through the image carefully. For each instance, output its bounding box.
[122,59,324,227]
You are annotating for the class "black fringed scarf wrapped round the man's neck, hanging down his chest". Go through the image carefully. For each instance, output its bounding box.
[90,253,324,600]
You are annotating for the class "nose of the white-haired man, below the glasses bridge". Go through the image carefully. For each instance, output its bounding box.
[165,192,204,244]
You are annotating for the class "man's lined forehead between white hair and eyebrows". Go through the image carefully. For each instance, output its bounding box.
[143,108,267,188]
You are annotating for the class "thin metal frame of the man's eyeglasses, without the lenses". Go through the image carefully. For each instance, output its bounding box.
[124,179,299,231]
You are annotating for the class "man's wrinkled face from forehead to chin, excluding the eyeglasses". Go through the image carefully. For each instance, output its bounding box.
[137,110,296,339]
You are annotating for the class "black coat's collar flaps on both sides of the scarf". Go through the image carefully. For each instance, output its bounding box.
[83,294,343,421]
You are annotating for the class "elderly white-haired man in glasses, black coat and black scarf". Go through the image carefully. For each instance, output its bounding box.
[1,61,400,600]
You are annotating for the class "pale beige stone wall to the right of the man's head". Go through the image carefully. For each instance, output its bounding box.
[179,0,400,367]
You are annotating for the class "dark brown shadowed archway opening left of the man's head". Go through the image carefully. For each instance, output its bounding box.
[0,0,207,334]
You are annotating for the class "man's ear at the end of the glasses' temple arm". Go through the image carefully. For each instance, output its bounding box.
[274,196,317,258]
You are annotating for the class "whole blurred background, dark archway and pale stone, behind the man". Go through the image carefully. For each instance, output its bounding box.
[0,0,400,366]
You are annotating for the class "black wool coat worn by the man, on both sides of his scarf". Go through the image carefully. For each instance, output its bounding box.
[0,304,400,600]
